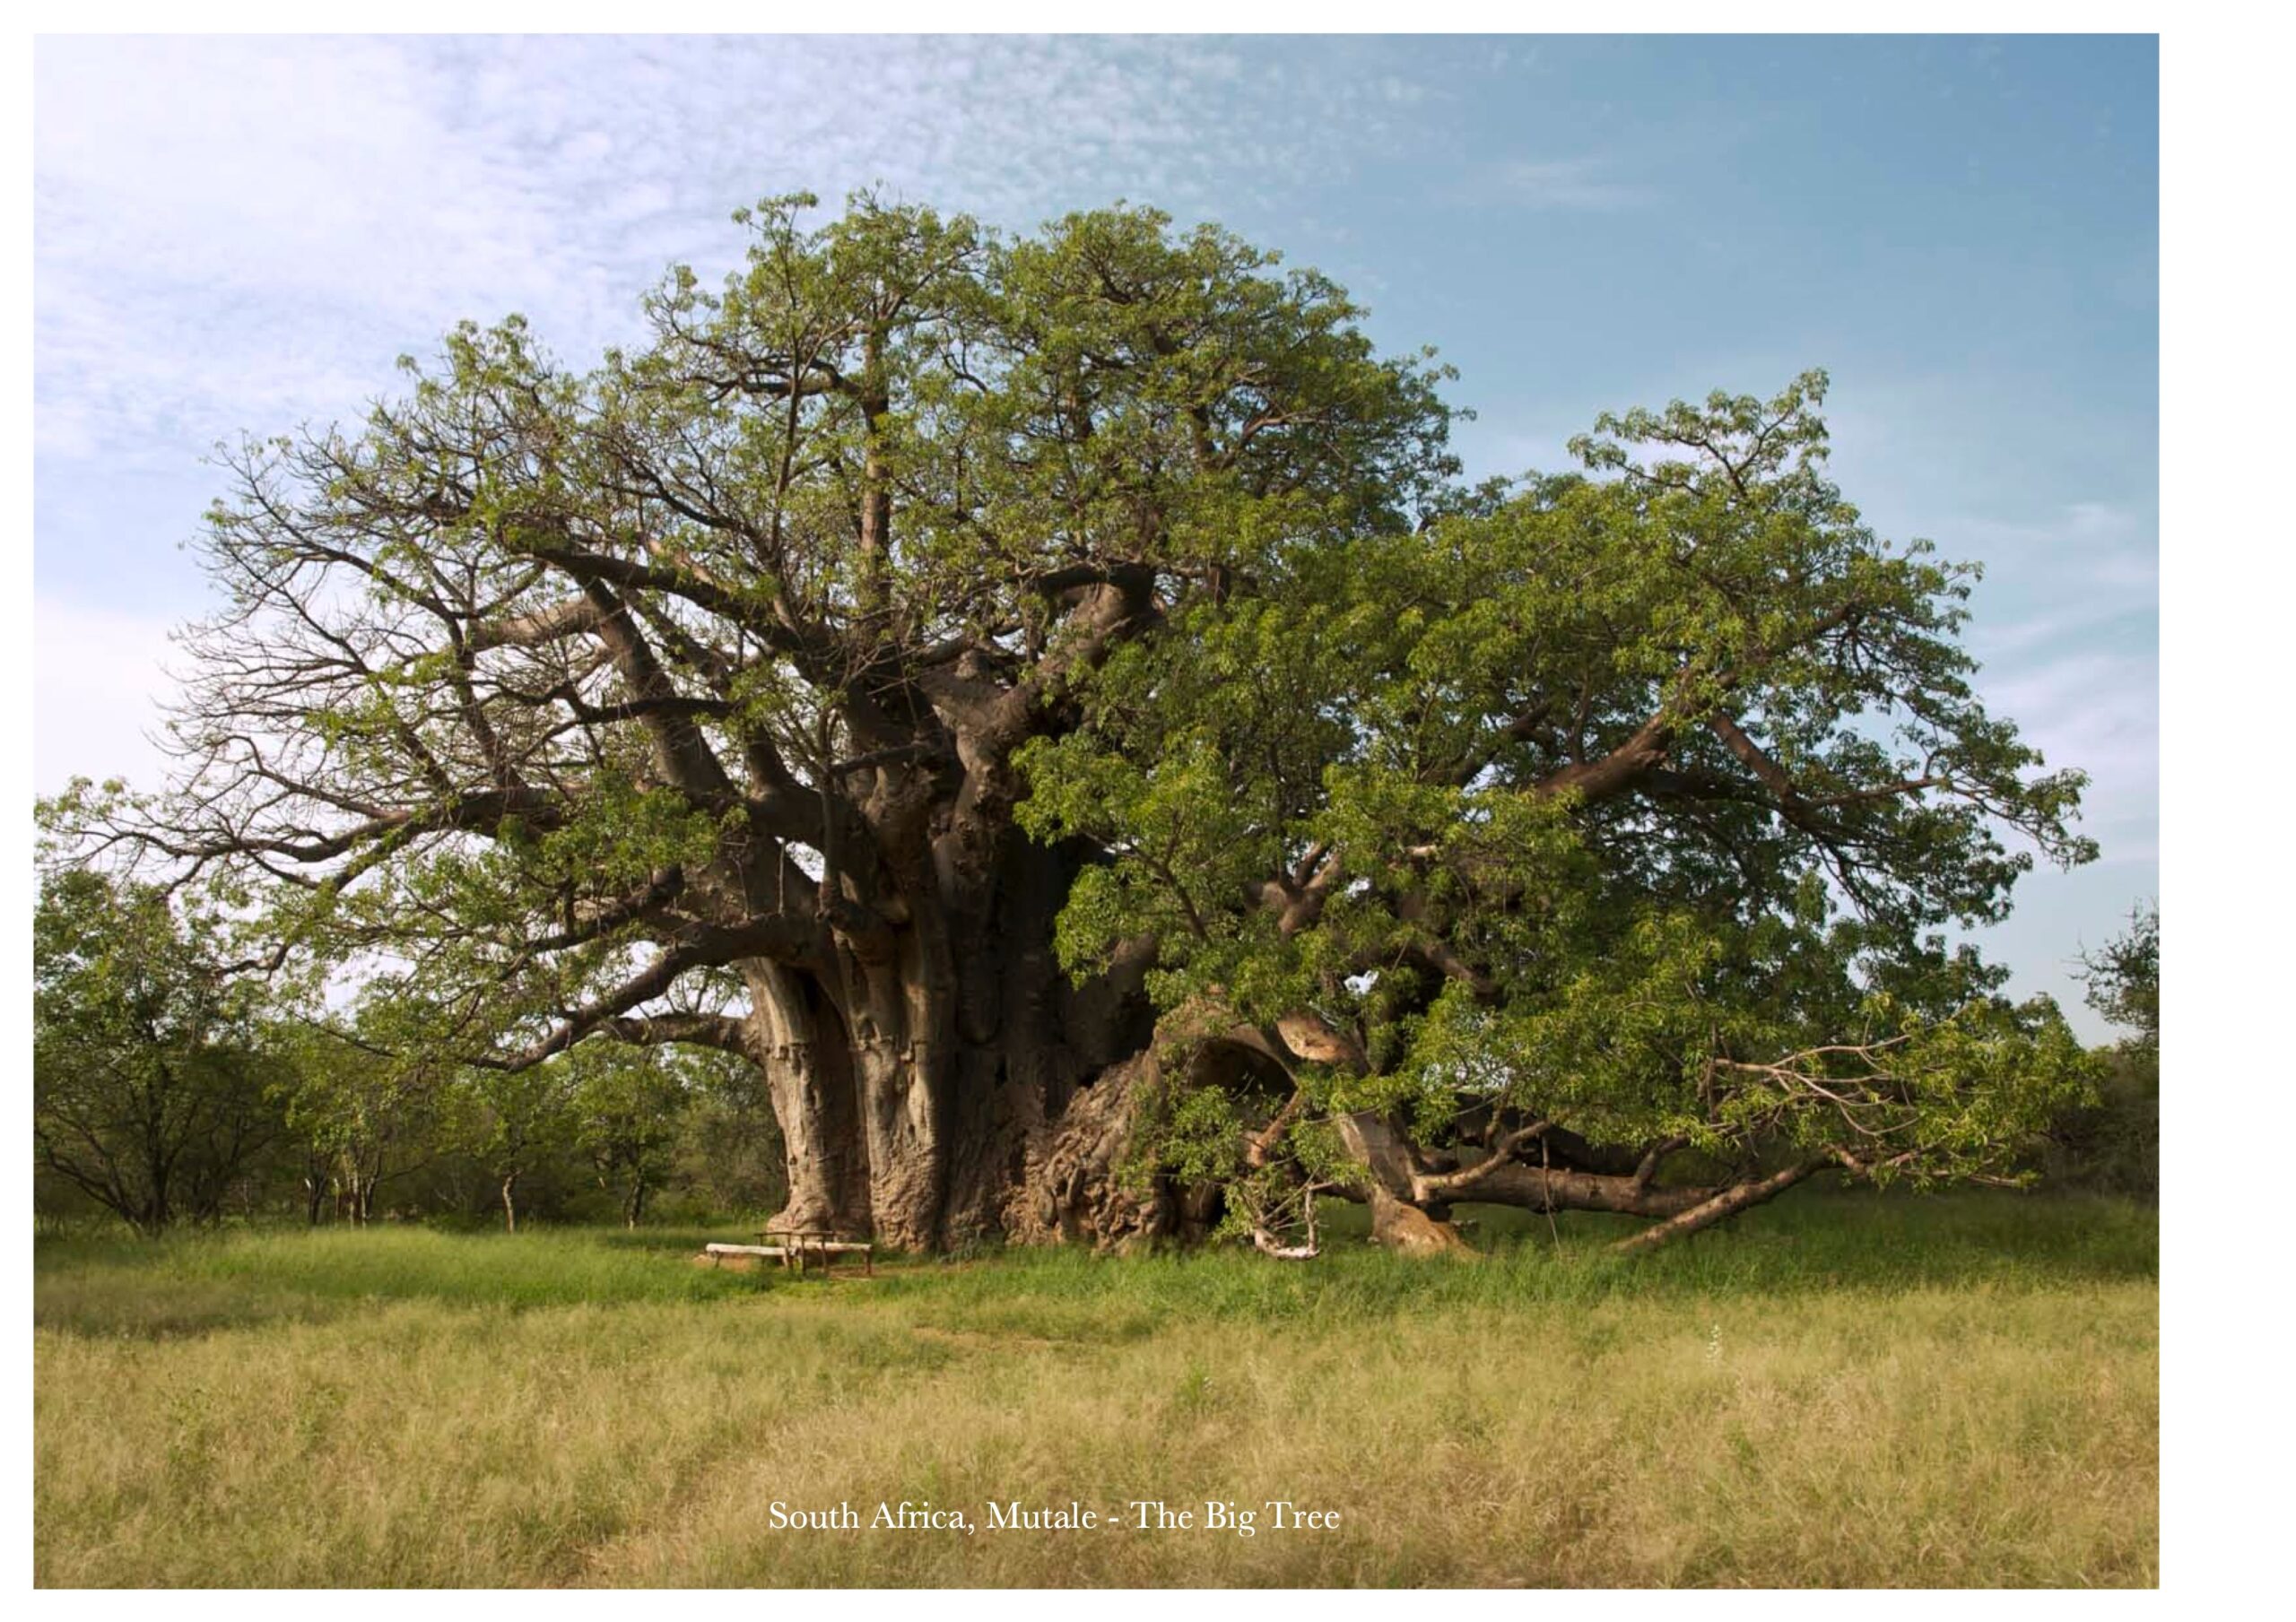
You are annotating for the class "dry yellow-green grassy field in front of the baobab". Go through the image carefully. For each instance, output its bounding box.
[34,1195,2158,1585]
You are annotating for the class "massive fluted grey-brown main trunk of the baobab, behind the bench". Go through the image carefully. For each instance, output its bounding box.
[737,830,1166,1250]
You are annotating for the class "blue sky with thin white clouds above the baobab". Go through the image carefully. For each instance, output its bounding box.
[34,37,2158,1035]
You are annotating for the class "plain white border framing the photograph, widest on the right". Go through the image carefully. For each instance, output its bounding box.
[0,0,2268,1622]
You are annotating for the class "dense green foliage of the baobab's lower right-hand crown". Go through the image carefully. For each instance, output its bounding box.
[1020,374,2094,1182]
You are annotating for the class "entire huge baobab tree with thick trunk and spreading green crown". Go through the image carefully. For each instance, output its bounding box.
[76,197,2084,1248]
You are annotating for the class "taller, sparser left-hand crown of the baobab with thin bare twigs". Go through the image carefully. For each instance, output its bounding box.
[49,193,1456,1064]
